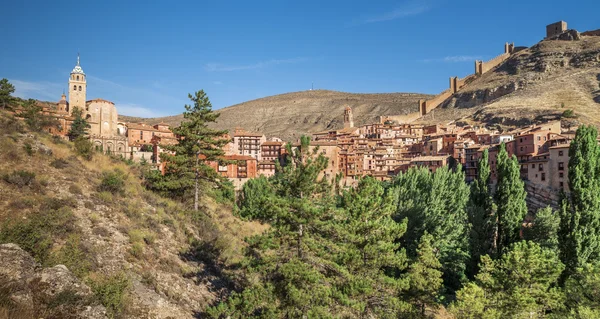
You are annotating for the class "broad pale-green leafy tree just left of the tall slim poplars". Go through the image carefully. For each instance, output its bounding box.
[394,165,469,289]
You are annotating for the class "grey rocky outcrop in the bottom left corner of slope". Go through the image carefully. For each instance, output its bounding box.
[0,244,107,319]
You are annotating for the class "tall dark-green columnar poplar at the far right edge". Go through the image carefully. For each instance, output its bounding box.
[559,125,600,275]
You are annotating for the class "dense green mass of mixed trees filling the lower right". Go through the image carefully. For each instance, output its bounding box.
[197,126,600,318]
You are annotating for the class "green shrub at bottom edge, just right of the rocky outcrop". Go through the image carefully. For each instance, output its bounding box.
[89,273,130,318]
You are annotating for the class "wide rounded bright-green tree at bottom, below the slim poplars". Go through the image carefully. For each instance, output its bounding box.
[476,241,564,318]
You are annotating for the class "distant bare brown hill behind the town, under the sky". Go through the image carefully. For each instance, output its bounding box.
[119,90,430,140]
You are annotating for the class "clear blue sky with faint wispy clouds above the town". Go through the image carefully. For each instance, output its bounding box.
[0,0,600,117]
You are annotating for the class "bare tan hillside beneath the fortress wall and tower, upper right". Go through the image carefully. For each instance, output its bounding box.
[424,31,600,126]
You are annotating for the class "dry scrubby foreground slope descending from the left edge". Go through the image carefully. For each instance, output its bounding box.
[0,111,264,318]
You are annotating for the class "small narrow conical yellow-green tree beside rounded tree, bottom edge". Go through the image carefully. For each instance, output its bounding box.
[406,232,443,315]
